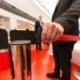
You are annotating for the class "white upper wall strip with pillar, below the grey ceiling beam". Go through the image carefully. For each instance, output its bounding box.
[0,8,35,29]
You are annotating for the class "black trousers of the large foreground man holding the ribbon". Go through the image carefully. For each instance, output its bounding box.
[53,43,74,80]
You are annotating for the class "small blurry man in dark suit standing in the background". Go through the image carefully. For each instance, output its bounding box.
[35,15,43,51]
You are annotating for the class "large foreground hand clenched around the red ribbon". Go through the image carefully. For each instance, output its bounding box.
[41,22,64,43]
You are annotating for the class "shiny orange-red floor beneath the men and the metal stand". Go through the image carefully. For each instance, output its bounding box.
[0,45,80,80]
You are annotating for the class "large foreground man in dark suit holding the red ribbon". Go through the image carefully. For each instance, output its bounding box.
[42,0,80,80]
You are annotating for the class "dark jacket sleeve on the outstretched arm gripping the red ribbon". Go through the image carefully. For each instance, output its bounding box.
[54,0,80,32]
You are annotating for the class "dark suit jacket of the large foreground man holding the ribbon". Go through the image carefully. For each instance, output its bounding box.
[52,0,80,43]
